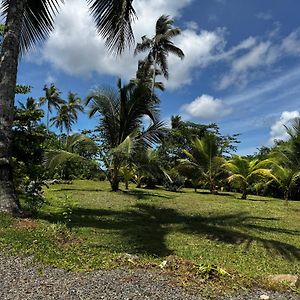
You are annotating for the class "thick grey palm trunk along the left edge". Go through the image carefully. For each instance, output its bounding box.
[0,0,26,213]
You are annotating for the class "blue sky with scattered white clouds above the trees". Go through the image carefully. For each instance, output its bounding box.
[18,0,300,154]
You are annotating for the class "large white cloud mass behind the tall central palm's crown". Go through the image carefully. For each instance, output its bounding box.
[34,0,225,89]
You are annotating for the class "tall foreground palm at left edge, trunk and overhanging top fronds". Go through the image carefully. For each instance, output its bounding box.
[0,0,135,213]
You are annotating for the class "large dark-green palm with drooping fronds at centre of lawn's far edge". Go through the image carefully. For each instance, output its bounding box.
[87,80,163,191]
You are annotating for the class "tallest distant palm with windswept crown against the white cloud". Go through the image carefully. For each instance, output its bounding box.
[135,15,184,94]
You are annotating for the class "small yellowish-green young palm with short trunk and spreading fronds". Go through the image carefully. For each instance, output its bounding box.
[223,155,276,199]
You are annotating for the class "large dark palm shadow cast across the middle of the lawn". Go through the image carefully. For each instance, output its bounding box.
[39,204,300,261]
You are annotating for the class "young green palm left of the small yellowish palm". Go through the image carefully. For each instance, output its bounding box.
[178,133,224,193]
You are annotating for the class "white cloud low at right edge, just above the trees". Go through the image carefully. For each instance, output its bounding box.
[269,110,300,144]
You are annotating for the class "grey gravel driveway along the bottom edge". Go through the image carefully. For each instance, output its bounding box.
[0,253,300,300]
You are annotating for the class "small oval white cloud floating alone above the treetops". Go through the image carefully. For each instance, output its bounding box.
[182,95,232,120]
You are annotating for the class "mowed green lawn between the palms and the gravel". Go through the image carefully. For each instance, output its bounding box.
[0,181,300,278]
